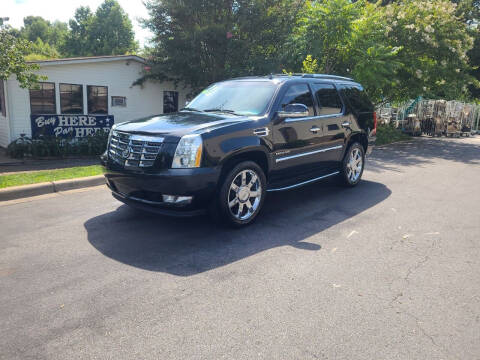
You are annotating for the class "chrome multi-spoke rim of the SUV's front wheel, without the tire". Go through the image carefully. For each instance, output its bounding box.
[227,170,262,220]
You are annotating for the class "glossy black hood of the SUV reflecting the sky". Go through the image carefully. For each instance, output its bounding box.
[115,111,248,137]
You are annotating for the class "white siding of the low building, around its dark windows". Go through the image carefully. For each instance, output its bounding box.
[0,59,188,146]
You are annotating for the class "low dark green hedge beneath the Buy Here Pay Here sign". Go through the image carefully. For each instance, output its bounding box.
[7,132,108,159]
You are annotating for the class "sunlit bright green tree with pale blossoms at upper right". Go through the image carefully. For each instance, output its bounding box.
[286,0,476,102]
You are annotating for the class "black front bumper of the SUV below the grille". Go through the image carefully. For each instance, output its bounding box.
[102,159,220,216]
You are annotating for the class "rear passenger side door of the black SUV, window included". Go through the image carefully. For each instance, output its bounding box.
[312,82,350,169]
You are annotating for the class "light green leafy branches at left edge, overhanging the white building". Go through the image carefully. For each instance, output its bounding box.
[0,29,43,88]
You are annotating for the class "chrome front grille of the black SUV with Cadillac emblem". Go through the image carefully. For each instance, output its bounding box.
[108,131,163,168]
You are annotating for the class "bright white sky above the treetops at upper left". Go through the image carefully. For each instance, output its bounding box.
[0,0,151,45]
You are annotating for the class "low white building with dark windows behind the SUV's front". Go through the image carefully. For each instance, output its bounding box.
[0,55,188,147]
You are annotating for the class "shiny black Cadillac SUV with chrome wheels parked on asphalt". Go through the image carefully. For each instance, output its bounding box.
[102,74,376,226]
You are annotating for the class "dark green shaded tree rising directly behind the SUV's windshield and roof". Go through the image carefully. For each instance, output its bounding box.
[143,0,301,90]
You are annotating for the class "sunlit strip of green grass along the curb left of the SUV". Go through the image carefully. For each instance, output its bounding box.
[0,165,102,189]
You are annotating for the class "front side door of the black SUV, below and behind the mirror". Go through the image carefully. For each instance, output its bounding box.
[271,82,321,181]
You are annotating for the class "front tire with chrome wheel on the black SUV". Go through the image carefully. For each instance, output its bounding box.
[210,161,267,228]
